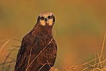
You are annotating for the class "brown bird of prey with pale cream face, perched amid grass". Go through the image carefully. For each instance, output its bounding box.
[14,12,57,71]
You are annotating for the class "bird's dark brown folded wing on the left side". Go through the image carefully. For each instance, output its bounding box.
[15,33,38,71]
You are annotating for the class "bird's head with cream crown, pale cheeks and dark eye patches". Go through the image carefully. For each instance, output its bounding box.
[37,12,55,26]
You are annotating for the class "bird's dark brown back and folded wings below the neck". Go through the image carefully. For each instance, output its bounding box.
[15,33,57,71]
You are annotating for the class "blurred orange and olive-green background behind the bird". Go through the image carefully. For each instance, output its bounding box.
[0,0,106,70]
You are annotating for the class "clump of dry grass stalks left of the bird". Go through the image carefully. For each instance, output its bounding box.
[0,39,19,71]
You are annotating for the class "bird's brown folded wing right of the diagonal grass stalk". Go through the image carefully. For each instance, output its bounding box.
[36,39,57,71]
